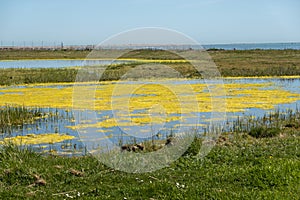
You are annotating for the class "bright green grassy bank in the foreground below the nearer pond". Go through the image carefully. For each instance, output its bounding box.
[0,108,300,199]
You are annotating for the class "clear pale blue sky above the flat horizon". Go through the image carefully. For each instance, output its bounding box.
[0,0,300,44]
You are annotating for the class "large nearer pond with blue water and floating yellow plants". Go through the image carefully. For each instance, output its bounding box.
[0,77,300,155]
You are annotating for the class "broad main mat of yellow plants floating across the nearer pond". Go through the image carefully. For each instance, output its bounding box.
[0,79,300,129]
